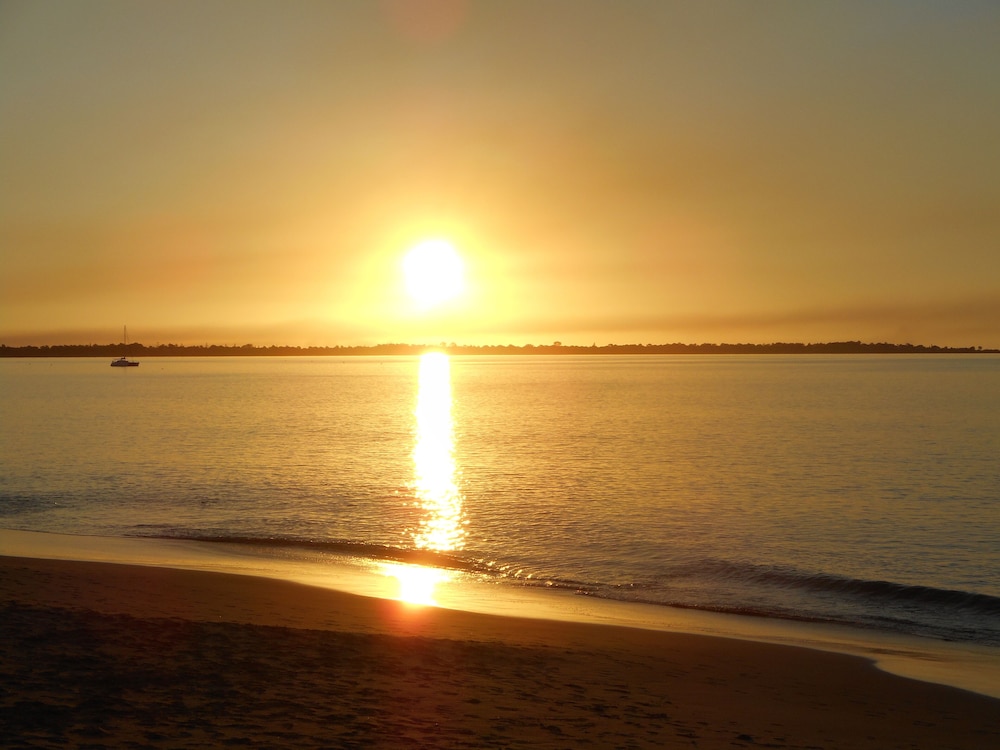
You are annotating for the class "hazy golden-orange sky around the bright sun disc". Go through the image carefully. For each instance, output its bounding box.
[0,0,1000,347]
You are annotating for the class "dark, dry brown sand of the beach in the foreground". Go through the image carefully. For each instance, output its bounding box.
[0,557,1000,750]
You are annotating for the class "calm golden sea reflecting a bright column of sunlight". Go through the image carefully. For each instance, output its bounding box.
[0,355,1000,646]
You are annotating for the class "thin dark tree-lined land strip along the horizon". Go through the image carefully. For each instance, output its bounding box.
[0,341,1000,358]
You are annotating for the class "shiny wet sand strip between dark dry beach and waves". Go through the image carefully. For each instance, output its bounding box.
[0,528,1000,699]
